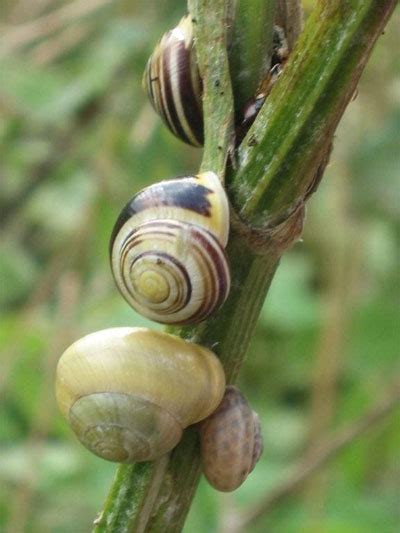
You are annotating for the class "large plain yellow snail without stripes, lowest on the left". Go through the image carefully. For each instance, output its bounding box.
[56,327,225,463]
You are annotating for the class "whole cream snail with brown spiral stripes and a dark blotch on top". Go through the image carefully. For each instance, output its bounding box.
[110,172,230,325]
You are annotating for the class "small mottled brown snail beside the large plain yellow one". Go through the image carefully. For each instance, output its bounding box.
[200,386,263,492]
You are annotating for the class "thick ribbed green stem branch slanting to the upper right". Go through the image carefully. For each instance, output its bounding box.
[230,0,397,227]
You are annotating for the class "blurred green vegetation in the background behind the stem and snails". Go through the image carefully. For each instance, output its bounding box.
[0,0,400,533]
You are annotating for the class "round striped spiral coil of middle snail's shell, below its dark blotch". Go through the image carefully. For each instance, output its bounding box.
[116,220,229,324]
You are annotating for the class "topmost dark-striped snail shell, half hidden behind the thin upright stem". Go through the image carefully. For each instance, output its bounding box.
[143,16,203,146]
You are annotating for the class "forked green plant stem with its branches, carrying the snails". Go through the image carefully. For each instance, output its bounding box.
[95,0,396,533]
